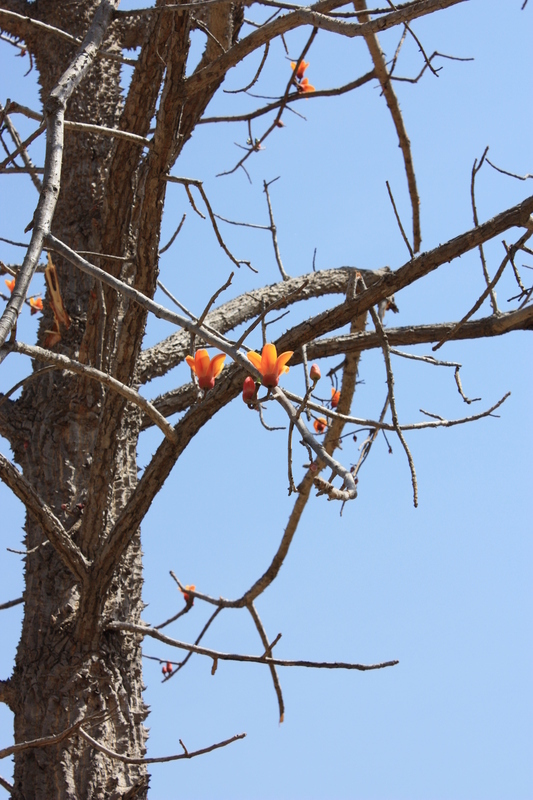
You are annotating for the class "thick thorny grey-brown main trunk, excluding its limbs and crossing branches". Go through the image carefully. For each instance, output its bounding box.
[8,0,147,800]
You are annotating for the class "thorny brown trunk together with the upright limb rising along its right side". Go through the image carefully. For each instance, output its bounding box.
[2,0,242,800]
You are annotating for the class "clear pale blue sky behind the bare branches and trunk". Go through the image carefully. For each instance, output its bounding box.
[0,0,533,800]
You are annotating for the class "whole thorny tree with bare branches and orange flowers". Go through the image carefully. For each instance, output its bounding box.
[0,0,533,798]
